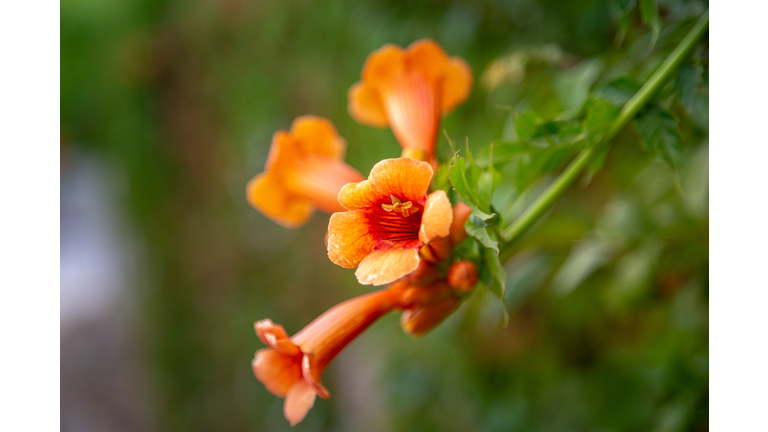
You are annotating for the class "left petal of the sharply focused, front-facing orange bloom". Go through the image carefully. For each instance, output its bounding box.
[328,211,374,268]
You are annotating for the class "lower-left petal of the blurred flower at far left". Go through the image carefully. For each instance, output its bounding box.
[245,173,314,228]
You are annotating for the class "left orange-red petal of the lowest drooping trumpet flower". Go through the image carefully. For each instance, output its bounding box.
[251,348,304,397]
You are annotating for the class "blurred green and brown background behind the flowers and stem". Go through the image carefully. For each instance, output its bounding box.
[61,0,709,431]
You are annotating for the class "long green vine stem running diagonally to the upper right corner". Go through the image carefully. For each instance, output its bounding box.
[500,9,709,263]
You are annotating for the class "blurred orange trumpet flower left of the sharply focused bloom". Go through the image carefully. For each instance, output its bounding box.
[246,116,363,228]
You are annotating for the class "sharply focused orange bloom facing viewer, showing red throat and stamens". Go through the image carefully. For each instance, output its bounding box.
[328,158,453,285]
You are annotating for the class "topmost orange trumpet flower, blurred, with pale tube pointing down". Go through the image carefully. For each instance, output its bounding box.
[347,39,472,160]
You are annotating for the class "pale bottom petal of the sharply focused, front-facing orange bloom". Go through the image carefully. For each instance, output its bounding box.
[355,248,419,285]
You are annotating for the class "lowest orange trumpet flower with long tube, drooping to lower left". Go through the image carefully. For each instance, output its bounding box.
[252,289,405,426]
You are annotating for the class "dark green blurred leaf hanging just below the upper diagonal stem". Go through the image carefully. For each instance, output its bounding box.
[637,106,683,170]
